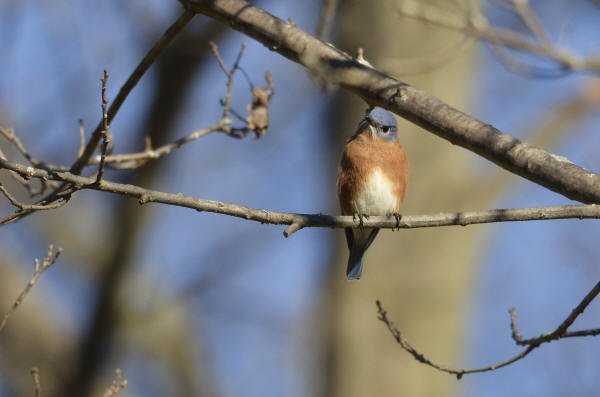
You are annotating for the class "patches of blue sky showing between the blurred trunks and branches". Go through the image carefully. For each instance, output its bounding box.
[0,1,600,396]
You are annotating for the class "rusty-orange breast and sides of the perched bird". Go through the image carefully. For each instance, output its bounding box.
[338,128,409,215]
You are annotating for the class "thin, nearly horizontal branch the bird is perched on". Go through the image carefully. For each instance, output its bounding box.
[0,159,600,232]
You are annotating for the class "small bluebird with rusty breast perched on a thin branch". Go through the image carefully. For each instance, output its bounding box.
[338,108,409,280]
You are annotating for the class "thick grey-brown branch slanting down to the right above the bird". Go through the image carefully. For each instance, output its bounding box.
[180,0,600,203]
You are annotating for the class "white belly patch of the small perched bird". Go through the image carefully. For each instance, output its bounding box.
[355,169,396,215]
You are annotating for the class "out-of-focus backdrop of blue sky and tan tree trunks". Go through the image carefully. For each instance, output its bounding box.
[0,0,600,397]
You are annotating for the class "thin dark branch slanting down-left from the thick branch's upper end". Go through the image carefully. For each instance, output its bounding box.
[71,11,194,174]
